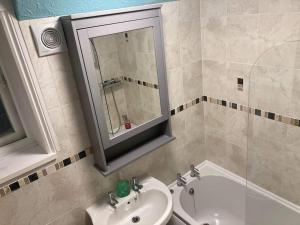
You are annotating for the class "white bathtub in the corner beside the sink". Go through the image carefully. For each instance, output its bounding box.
[169,161,300,225]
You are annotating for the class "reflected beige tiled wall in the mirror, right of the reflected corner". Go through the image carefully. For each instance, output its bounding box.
[117,28,161,125]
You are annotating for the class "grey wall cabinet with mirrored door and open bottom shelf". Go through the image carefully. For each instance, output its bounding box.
[62,5,174,175]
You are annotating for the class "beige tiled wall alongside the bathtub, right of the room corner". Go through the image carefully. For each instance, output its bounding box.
[201,0,300,205]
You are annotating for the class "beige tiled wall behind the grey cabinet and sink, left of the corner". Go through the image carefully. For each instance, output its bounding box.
[0,0,206,225]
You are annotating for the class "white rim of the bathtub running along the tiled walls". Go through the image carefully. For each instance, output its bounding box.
[169,160,300,214]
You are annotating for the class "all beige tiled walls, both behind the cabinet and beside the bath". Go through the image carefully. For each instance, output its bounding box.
[0,0,300,225]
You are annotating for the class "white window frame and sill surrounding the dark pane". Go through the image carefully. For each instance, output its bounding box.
[0,1,59,186]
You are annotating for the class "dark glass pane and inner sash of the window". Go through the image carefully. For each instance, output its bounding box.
[0,67,26,147]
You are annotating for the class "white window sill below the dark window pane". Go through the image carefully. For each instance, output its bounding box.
[0,140,56,186]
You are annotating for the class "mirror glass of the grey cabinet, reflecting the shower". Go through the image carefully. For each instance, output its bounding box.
[91,27,162,138]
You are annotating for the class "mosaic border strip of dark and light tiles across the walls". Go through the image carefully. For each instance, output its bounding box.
[0,95,300,199]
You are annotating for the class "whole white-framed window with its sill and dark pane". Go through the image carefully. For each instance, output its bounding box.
[0,7,58,186]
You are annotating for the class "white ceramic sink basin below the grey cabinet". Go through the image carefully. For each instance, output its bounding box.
[87,177,173,225]
